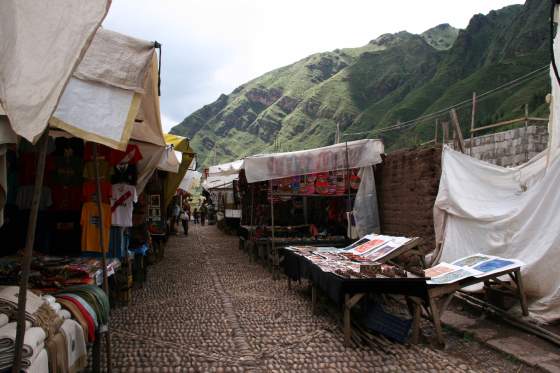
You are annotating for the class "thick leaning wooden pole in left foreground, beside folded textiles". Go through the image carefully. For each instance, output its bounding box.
[12,130,49,373]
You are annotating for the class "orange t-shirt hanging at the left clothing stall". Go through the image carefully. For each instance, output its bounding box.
[80,202,111,253]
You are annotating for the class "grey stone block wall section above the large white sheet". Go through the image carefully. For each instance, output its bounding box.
[466,125,548,166]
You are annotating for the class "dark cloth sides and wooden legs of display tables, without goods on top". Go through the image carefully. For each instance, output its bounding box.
[280,248,528,346]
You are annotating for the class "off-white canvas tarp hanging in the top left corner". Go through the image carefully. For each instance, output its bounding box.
[0,0,110,143]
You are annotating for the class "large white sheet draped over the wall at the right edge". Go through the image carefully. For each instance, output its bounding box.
[434,147,560,321]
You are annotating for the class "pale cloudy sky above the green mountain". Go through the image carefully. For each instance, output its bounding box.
[104,0,523,130]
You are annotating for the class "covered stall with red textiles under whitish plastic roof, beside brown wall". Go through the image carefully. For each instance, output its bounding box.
[239,139,383,274]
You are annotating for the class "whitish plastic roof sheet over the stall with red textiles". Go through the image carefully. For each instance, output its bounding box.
[244,139,384,183]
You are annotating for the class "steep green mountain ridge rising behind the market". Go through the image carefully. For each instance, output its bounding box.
[171,0,550,165]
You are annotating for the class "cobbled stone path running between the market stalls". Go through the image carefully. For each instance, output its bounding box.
[106,225,540,372]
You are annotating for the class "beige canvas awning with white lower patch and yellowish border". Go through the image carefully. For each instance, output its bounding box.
[50,29,158,150]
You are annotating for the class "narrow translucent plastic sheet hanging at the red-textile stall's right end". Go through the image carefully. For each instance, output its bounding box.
[353,166,381,237]
